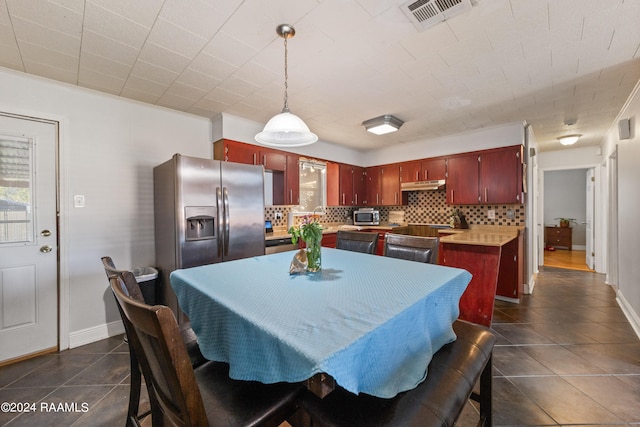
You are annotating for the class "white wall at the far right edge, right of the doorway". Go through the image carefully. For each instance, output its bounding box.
[603,82,640,335]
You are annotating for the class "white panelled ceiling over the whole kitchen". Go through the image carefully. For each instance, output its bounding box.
[0,0,640,151]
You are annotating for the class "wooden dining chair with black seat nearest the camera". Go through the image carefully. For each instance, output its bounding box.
[110,271,304,427]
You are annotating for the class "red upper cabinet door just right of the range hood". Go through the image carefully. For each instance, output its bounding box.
[447,153,480,205]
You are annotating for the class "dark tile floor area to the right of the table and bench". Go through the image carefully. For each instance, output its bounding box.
[459,267,640,427]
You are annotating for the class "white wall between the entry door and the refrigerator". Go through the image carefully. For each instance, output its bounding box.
[0,69,213,347]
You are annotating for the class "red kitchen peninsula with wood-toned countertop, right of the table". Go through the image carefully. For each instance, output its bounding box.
[438,226,524,326]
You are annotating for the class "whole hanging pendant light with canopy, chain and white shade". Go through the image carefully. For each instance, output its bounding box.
[255,24,318,147]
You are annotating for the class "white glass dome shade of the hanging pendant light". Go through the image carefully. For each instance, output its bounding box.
[256,111,318,147]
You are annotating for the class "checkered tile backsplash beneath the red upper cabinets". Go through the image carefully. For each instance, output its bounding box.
[264,190,525,227]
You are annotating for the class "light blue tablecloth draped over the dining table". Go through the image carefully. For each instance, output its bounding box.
[171,248,471,398]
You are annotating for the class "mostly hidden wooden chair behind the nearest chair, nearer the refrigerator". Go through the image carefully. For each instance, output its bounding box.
[101,256,207,427]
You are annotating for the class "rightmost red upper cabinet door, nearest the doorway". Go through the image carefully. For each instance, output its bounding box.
[480,145,522,204]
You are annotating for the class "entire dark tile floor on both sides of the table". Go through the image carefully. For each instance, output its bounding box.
[0,268,640,427]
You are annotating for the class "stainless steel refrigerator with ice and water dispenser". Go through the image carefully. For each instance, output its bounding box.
[153,154,265,322]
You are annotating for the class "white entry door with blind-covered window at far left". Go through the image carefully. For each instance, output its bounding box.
[0,115,58,362]
